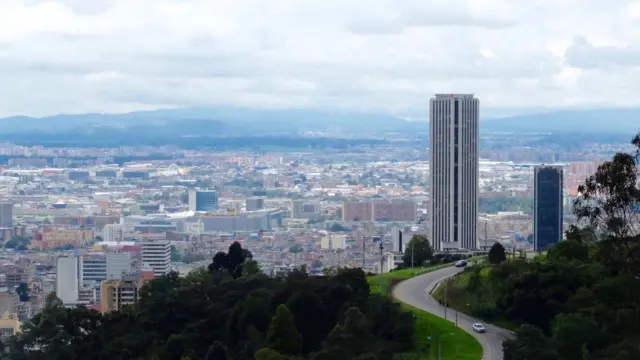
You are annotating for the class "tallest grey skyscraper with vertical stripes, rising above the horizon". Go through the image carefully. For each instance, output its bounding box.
[429,94,480,250]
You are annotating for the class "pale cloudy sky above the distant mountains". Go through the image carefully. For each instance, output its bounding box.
[0,0,640,118]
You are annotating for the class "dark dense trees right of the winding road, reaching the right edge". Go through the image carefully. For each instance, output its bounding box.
[502,134,640,360]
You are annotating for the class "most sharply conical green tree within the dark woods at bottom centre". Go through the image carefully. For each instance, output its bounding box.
[267,304,302,355]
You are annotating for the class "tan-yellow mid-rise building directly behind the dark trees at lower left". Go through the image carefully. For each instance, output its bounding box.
[100,275,144,313]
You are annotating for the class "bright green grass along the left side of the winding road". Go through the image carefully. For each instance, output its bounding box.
[368,264,482,360]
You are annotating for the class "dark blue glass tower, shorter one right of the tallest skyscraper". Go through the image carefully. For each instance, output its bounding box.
[533,165,564,251]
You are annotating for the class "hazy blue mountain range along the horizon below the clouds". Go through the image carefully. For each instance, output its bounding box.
[0,107,640,137]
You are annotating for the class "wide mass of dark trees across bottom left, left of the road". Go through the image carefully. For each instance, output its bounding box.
[0,243,414,360]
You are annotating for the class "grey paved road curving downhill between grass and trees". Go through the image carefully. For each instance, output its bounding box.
[393,267,511,360]
